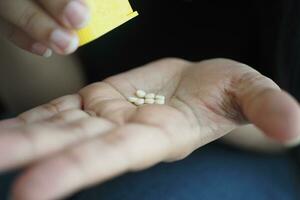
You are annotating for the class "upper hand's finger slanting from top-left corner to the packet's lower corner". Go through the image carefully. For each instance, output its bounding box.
[0,0,78,54]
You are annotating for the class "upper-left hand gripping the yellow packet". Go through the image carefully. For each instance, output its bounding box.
[0,0,89,57]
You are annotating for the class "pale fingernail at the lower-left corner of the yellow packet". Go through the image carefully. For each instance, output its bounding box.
[50,29,79,54]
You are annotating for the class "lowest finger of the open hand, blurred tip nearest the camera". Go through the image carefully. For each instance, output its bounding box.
[14,125,170,200]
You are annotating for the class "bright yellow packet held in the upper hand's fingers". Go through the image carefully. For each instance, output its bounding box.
[77,0,138,46]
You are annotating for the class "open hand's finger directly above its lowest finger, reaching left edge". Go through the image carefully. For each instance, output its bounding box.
[0,115,114,171]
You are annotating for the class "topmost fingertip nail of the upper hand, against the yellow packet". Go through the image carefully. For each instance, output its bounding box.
[64,0,90,29]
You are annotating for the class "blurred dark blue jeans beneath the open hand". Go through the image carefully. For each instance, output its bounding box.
[0,143,300,200]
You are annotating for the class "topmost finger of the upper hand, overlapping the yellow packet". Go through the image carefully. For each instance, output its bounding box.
[38,0,90,29]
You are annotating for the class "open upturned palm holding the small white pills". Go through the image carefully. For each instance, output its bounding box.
[0,59,300,200]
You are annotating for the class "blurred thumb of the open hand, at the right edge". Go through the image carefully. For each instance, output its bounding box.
[237,71,300,146]
